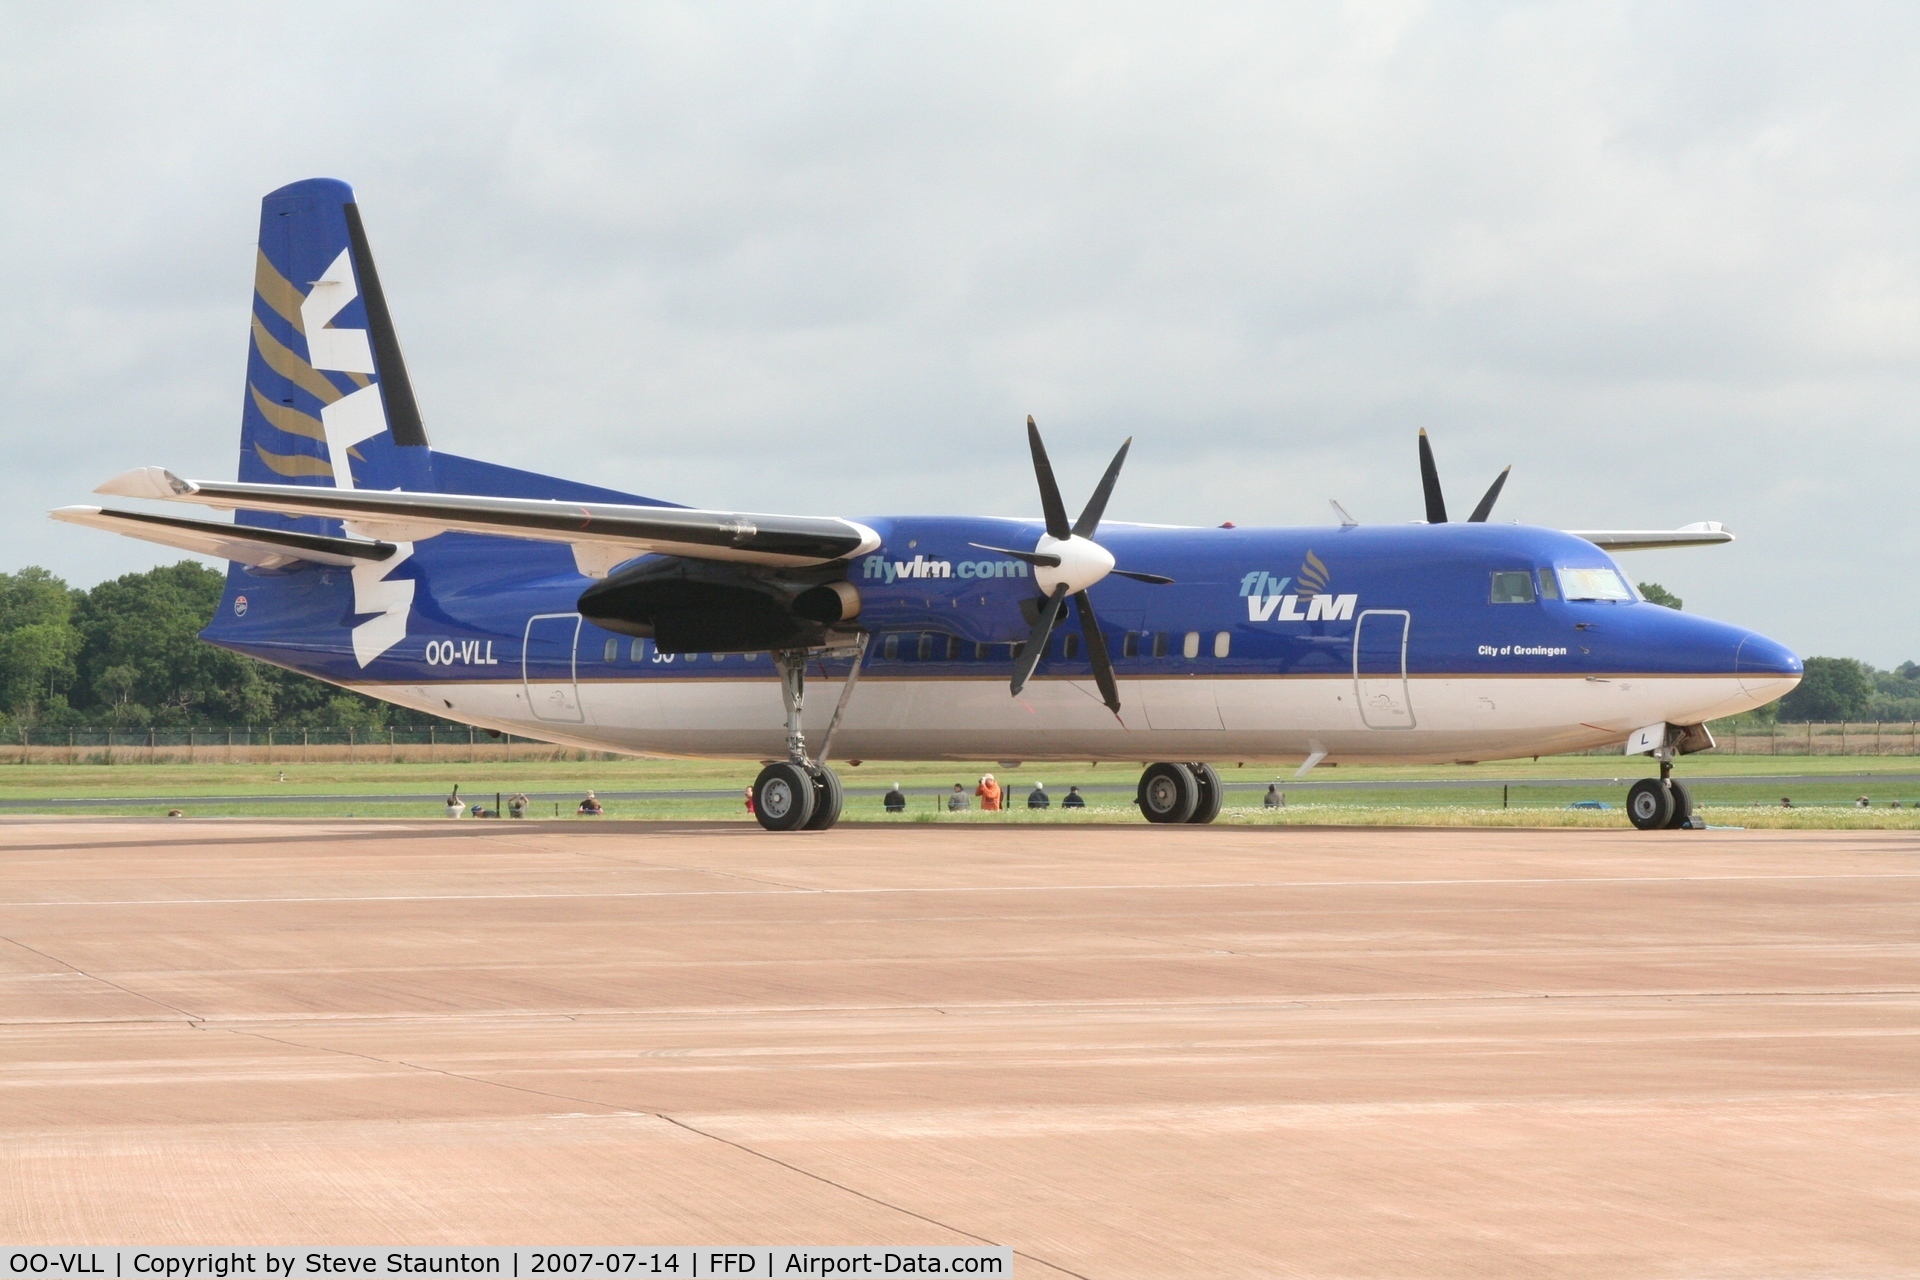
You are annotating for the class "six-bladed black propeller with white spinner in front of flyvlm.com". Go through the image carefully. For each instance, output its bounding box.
[970,415,1173,716]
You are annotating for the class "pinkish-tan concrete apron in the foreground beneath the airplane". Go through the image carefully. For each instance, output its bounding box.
[0,819,1920,1278]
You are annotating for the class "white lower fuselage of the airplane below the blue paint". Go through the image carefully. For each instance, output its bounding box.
[353,671,1797,762]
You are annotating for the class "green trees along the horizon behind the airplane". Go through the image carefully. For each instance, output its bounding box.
[0,560,1920,729]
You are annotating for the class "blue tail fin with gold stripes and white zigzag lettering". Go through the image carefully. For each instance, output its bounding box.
[240,178,432,498]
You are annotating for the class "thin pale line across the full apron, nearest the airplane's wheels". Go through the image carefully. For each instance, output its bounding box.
[0,869,1920,912]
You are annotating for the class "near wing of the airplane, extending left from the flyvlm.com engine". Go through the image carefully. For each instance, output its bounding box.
[94,466,879,578]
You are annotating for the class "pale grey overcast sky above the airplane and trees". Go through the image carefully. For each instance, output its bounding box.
[0,4,1920,666]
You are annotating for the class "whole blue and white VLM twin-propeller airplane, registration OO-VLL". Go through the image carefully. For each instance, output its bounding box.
[52,178,1801,831]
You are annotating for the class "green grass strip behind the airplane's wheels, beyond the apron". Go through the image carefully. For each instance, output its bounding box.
[0,754,1920,827]
